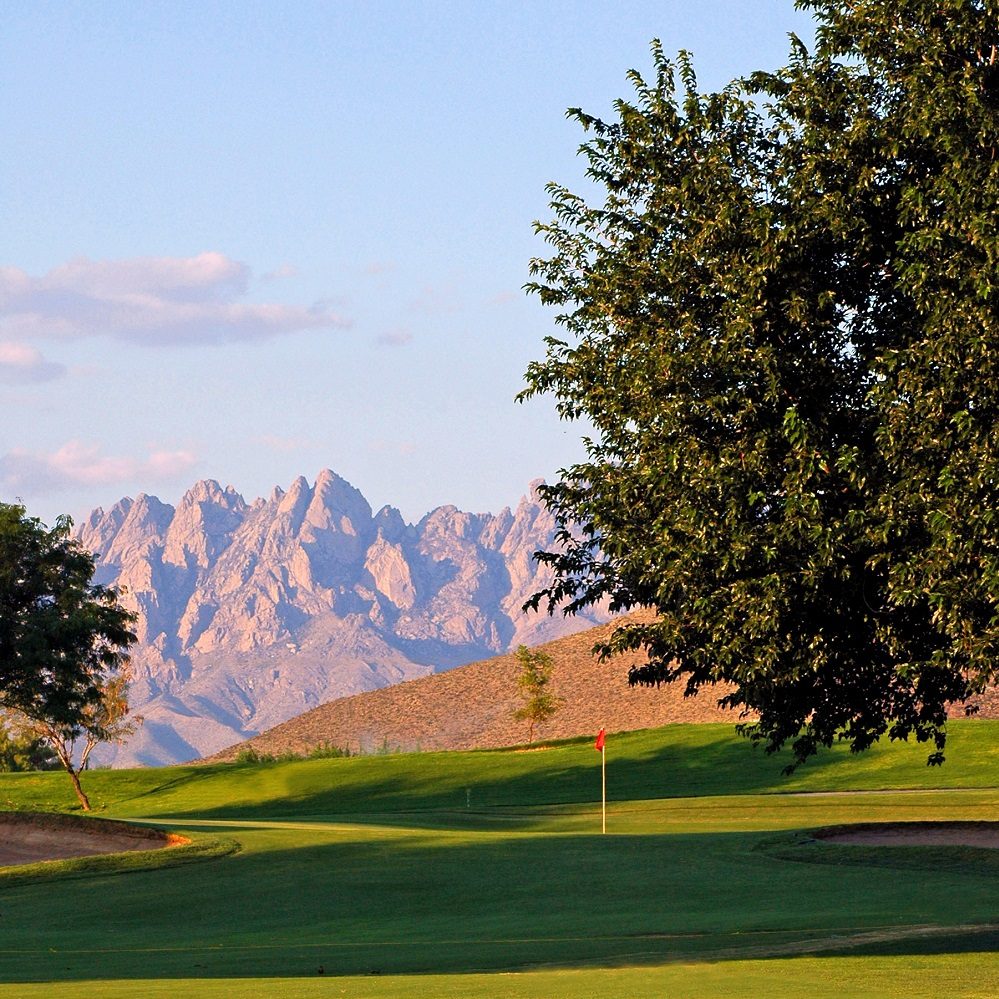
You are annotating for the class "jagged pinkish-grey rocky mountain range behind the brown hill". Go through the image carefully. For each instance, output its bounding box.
[77,469,608,765]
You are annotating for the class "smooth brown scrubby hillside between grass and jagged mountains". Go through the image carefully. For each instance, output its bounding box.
[205,622,738,762]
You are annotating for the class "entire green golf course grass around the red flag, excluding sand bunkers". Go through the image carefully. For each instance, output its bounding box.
[0,721,999,997]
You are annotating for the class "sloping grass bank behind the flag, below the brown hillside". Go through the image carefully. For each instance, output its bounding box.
[7,721,999,821]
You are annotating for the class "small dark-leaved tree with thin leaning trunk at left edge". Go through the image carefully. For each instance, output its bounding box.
[0,503,136,811]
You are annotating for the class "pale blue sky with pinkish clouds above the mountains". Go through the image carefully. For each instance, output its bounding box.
[0,0,812,523]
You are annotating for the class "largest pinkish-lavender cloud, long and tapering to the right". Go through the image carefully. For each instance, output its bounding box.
[0,253,348,345]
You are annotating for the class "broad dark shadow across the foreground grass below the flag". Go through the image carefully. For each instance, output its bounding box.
[0,828,999,982]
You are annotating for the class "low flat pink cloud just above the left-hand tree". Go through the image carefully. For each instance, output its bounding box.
[0,441,197,495]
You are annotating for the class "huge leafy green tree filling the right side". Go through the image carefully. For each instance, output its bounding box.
[524,0,999,762]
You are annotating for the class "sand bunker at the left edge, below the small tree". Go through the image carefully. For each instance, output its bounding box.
[0,812,190,867]
